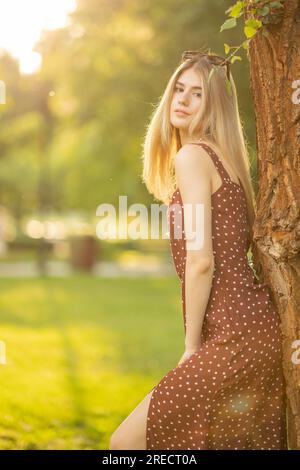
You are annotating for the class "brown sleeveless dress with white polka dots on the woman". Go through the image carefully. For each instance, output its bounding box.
[146,143,288,450]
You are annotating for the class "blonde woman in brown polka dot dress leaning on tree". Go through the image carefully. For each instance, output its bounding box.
[110,51,287,450]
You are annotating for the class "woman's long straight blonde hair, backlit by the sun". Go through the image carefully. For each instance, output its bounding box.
[142,50,256,250]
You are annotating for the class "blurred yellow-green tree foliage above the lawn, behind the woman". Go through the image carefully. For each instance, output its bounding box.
[0,0,255,266]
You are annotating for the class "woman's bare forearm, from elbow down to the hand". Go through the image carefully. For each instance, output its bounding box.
[185,258,214,351]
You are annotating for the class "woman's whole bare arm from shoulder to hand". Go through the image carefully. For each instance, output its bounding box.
[174,144,214,352]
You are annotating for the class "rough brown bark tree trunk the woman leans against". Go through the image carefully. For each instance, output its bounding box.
[249,0,300,449]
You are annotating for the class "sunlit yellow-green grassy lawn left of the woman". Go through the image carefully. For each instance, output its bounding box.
[0,274,183,449]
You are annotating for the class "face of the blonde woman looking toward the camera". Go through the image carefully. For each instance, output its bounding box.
[170,68,202,131]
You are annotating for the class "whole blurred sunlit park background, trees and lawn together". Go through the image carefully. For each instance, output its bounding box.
[0,0,256,449]
